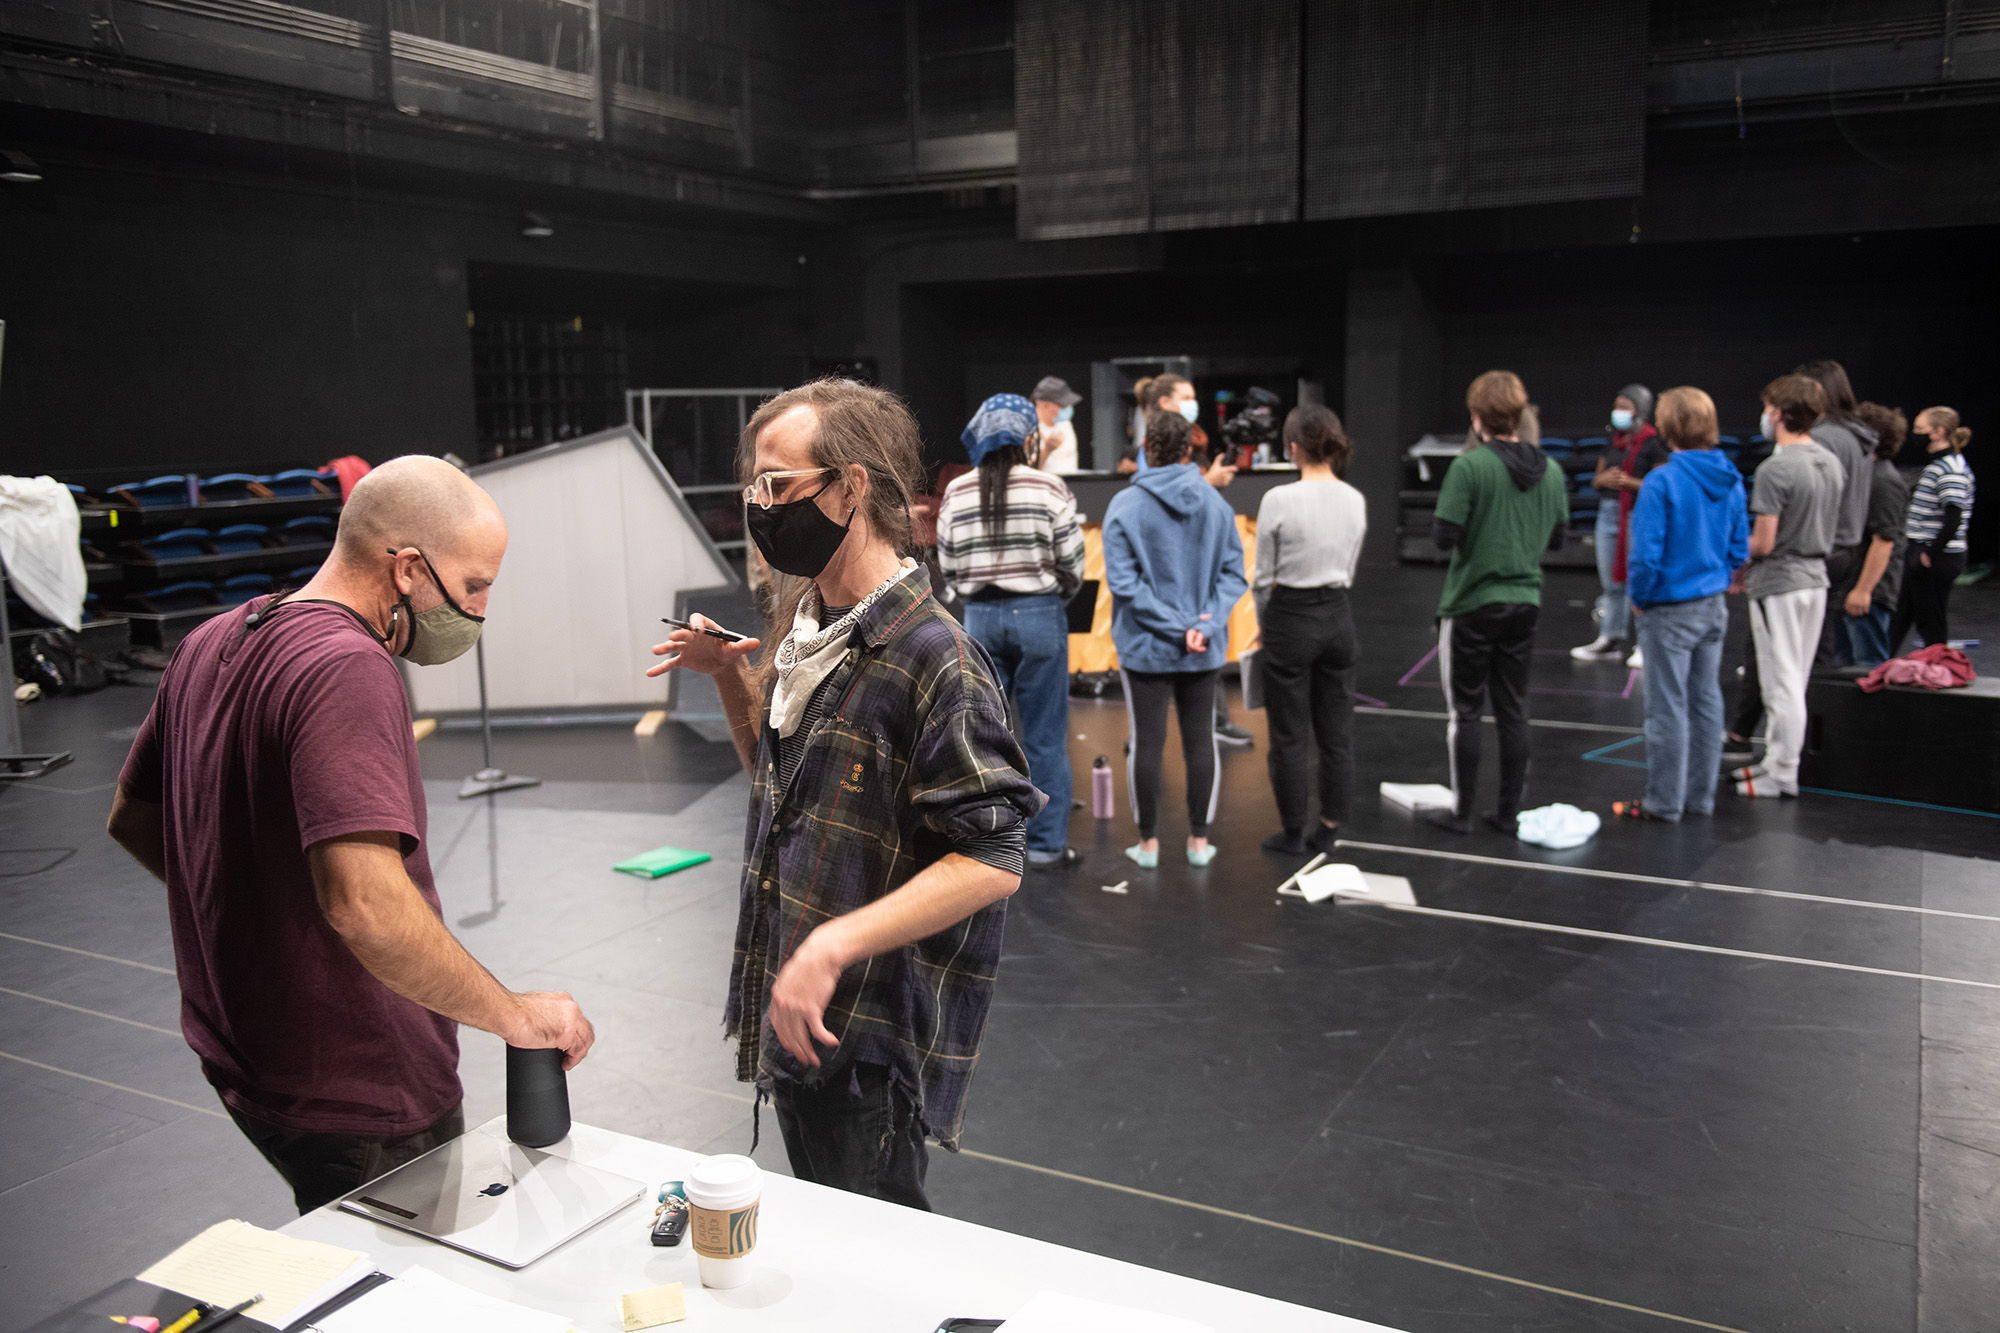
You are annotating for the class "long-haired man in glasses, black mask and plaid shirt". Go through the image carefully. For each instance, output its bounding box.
[648,380,1042,1209]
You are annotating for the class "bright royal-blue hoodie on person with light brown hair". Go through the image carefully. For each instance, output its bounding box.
[1626,448,1750,606]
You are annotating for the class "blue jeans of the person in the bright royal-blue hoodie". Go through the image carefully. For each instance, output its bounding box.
[1638,592,1730,819]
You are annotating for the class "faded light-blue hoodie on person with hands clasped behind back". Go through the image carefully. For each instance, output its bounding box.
[1104,462,1250,671]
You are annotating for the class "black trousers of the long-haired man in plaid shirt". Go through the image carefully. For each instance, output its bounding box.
[772,1061,930,1213]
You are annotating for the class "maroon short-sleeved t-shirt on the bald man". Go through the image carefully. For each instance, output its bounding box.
[118,598,464,1135]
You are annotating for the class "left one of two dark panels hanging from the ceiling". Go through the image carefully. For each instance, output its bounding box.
[1014,0,1300,240]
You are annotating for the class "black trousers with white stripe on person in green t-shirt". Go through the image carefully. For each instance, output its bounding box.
[1438,602,1542,821]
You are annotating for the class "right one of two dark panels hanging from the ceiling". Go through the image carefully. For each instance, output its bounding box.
[1304,0,1646,218]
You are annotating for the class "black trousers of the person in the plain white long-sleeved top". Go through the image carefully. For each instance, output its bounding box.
[1258,584,1360,833]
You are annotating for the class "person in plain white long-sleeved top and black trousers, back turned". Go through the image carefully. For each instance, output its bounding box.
[1250,402,1368,855]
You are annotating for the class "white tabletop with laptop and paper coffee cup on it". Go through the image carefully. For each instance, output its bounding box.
[284,1119,1390,1333]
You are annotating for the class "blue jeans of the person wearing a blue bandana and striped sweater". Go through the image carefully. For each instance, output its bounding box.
[966,592,1070,853]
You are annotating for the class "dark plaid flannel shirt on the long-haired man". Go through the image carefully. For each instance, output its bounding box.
[722,572,1042,1149]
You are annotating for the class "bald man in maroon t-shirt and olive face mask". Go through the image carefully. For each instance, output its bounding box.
[110,456,594,1213]
